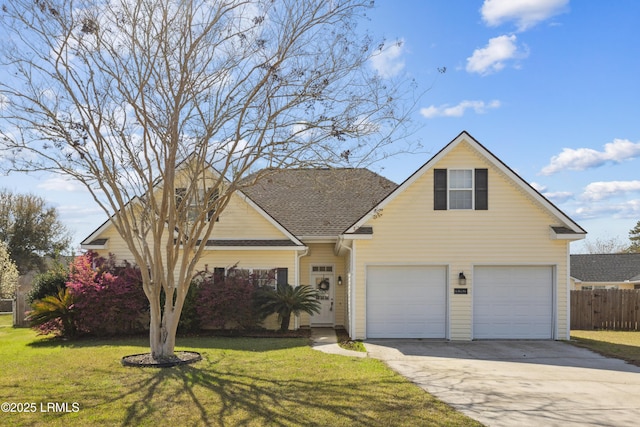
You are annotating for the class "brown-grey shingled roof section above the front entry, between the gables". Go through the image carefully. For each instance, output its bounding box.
[242,168,397,237]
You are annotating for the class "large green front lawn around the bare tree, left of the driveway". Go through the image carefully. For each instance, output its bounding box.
[0,315,480,426]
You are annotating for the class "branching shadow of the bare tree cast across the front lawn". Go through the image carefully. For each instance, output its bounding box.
[115,365,402,426]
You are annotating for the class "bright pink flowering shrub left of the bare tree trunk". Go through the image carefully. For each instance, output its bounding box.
[67,252,149,336]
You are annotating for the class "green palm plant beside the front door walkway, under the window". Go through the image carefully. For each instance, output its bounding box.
[260,284,320,332]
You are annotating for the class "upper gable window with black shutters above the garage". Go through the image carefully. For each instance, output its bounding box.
[433,169,489,210]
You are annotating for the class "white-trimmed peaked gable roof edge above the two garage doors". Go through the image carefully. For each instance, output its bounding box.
[343,131,587,240]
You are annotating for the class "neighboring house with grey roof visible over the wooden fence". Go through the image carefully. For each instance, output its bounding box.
[571,253,640,291]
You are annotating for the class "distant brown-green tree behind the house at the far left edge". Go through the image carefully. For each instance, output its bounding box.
[0,190,70,274]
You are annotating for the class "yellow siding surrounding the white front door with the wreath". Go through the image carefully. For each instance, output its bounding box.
[300,243,347,326]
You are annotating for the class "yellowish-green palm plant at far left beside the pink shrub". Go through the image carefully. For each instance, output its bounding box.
[27,288,76,337]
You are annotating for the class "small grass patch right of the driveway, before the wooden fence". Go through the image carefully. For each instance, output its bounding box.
[571,331,640,366]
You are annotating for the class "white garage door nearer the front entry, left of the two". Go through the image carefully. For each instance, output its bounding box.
[366,266,447,338]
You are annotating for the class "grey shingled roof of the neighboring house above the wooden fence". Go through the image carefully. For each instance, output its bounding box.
[571,253,640,283]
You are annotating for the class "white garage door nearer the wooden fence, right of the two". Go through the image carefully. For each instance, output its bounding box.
[473,266,553,339]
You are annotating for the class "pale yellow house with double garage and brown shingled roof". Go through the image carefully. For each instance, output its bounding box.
[83,132,586,340]
